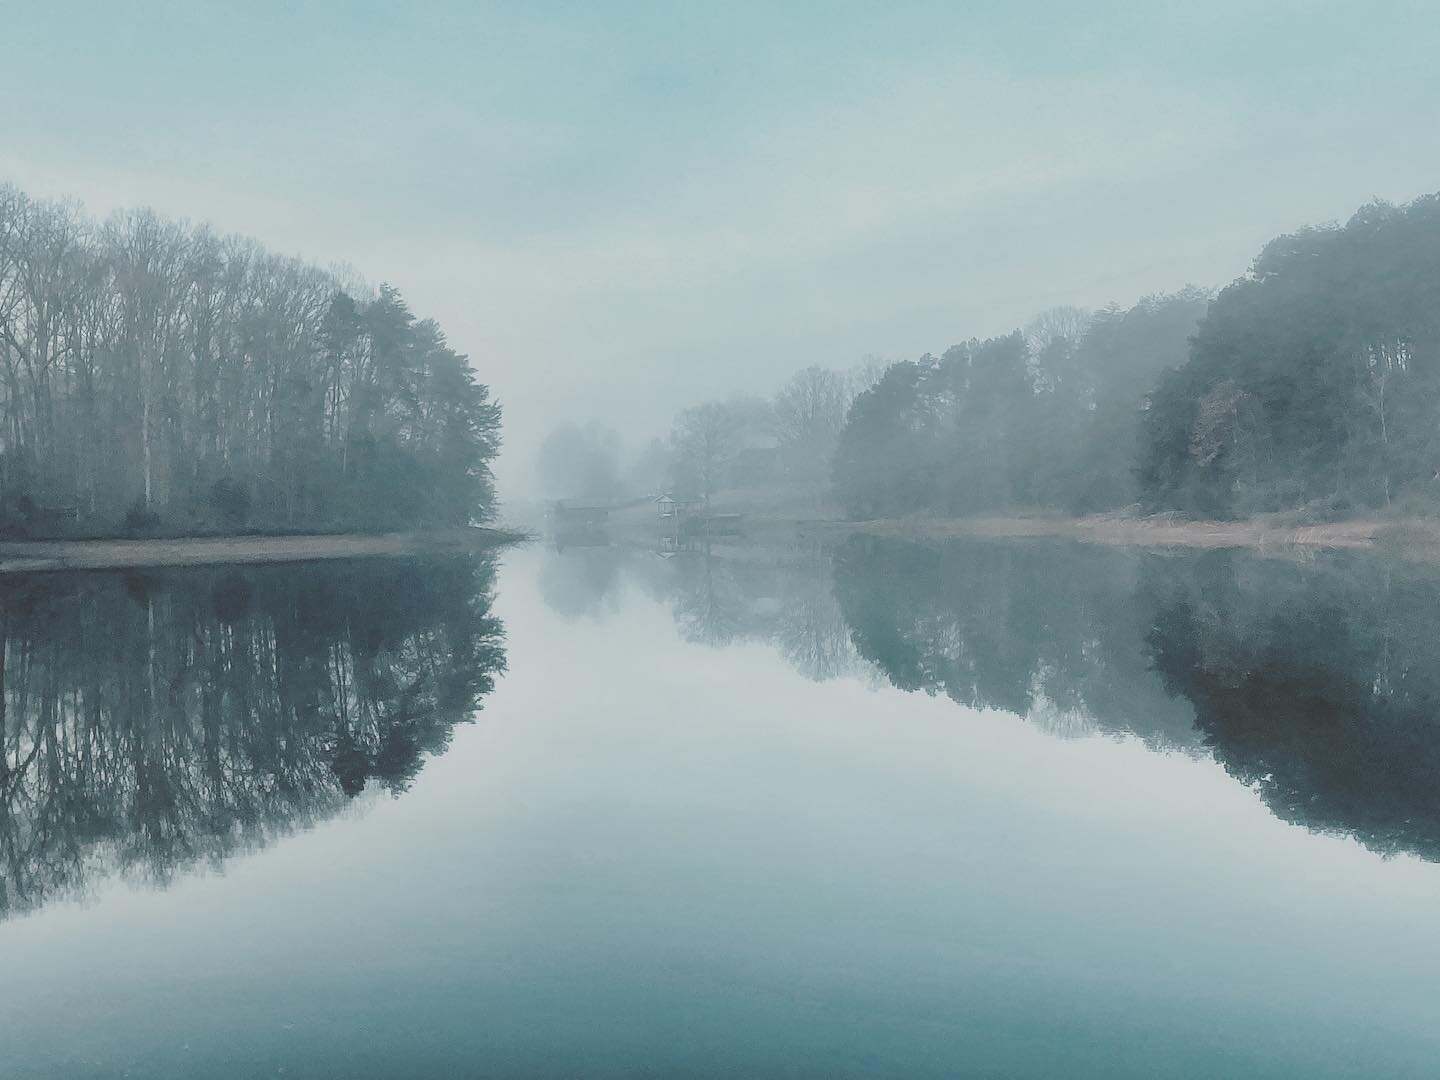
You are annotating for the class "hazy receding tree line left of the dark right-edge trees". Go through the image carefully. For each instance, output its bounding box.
[539,288,1211,517]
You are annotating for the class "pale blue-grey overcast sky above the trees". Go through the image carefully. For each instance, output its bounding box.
[0,0,1440,491]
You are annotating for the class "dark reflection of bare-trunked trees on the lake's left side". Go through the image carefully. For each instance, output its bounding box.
[0,559,504,917]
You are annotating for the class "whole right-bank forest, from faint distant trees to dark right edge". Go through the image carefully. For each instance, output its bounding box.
[540,196,1440,521]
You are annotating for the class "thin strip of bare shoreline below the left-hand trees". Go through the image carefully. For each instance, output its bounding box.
[0,526,528,575]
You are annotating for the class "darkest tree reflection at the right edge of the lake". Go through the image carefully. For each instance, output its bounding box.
[1148,556,1440,861]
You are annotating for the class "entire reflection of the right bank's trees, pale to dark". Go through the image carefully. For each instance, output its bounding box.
[546,536,1440,861]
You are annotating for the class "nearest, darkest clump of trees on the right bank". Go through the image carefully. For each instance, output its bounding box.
[1139,196,1440,516]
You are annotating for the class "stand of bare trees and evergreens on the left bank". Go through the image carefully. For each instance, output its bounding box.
[0,186,500,537]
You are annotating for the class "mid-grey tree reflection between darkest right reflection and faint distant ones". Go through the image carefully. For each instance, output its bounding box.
[835,537,1197,747]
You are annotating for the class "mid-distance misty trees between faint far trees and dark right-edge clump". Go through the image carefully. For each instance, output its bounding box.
[834,289,1208,517]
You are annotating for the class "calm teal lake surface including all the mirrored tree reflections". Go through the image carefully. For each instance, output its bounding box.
[0,540,1440,1077]
